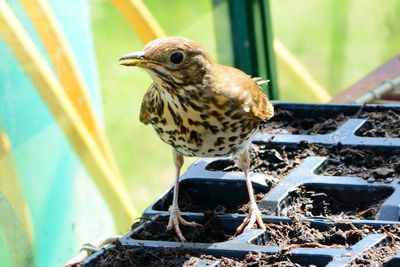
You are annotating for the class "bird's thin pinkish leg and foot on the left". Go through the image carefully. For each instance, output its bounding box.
[167,149,201,242]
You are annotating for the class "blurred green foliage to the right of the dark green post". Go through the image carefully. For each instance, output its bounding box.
[271,0,400,101]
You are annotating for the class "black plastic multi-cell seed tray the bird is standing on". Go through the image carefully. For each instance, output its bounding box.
[83,103,400,266]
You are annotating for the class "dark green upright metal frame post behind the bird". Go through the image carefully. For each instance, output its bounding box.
[227,0,278,99]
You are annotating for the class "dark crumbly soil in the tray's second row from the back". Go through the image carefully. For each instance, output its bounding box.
[206,142,400,183]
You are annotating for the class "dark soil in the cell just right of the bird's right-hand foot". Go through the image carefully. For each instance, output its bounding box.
[281,186,391,220]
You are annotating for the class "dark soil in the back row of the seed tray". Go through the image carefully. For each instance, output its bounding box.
[261,108,400,137]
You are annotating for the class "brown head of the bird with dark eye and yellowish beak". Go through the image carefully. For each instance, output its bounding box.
[119,37,213,85]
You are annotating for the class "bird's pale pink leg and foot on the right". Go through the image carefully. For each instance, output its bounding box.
[236,149,265,234]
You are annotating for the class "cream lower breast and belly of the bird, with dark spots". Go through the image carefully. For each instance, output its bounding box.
[151,93,259,157]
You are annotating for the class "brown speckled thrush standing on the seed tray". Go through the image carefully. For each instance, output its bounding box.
[119,36,274,241]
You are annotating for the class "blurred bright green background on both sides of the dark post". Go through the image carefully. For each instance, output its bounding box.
[91,0,400,214]
